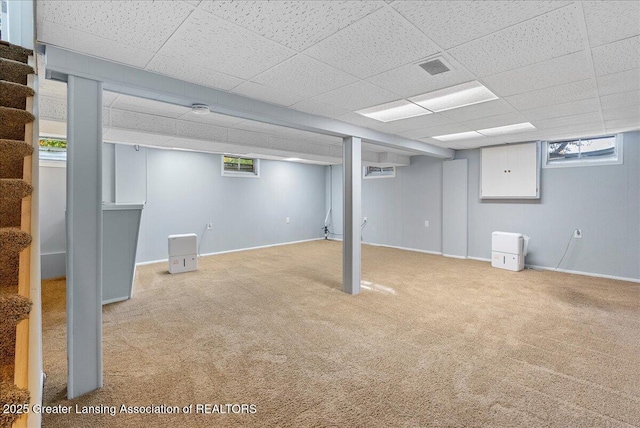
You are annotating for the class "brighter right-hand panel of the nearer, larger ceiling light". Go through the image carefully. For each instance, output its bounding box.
[409,80,498,112]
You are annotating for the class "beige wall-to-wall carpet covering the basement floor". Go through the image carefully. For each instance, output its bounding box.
[43,241,640,427]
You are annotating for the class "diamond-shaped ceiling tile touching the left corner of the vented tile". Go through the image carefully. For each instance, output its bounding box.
[251,54,358,98]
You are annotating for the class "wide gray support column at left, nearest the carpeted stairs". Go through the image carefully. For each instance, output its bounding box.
[67,76,102,399]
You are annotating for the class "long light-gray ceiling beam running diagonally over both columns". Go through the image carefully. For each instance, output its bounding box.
[46,46,455,159]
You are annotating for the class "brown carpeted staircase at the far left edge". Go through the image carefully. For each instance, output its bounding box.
[0,42,35,428]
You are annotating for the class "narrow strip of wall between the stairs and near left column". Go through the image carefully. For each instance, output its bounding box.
[39,166,67,279]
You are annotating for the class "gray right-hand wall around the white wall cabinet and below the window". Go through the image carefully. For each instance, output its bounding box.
[456,132,640,279]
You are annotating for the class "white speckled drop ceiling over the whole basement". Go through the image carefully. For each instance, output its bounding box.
[37,0,640,157]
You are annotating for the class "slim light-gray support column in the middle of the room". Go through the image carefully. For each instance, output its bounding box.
[342,137,362,294]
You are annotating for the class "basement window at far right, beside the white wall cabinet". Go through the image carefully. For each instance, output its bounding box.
[543,134,622,168]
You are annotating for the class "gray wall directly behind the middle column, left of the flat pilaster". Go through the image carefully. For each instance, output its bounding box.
[327,156,442,252]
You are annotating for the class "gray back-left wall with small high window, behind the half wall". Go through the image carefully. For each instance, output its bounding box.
[116,146,325,262]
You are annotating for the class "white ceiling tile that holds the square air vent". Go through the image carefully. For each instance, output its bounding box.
[367,55,475,98]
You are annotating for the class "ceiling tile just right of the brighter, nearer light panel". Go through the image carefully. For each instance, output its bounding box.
[505,79,598,110]
